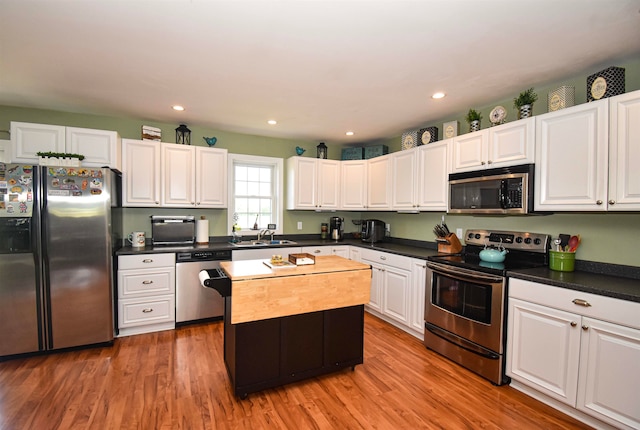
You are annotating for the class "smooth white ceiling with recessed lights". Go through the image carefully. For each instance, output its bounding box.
[0,0,640,143]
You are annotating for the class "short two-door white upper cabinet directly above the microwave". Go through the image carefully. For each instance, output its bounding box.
[452,117,535,172]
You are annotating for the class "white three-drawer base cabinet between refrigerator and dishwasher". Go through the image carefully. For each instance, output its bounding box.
[117,253,176,336]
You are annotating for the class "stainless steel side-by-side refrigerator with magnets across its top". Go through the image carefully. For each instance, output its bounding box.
[0,163,117,357]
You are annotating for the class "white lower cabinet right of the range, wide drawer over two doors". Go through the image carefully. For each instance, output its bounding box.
[507,279,640,429]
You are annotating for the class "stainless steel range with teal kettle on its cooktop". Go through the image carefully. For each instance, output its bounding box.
[424,230,551,385]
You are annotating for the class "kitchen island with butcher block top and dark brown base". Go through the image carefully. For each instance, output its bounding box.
[220,255,371,398]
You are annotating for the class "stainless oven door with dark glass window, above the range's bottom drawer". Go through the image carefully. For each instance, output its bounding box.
[425,262,505,354]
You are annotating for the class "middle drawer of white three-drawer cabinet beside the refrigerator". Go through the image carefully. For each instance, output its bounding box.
[118,269,175,299]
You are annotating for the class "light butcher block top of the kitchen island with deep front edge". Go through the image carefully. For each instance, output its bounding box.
[220,255,371,324]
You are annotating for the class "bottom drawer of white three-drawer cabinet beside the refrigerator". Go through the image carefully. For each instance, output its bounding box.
[118,295,176,328]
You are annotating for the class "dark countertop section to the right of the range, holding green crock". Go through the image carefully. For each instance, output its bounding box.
[507,267,640,302]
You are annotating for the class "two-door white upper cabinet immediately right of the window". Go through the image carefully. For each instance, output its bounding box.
[287,157,341,210]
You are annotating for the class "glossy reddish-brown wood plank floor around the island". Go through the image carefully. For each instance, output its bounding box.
[0,314,586,430]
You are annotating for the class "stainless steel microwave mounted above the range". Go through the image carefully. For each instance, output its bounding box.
[448,164,534,215]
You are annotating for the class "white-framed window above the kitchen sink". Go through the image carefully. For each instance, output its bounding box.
[228,154,284,235]
